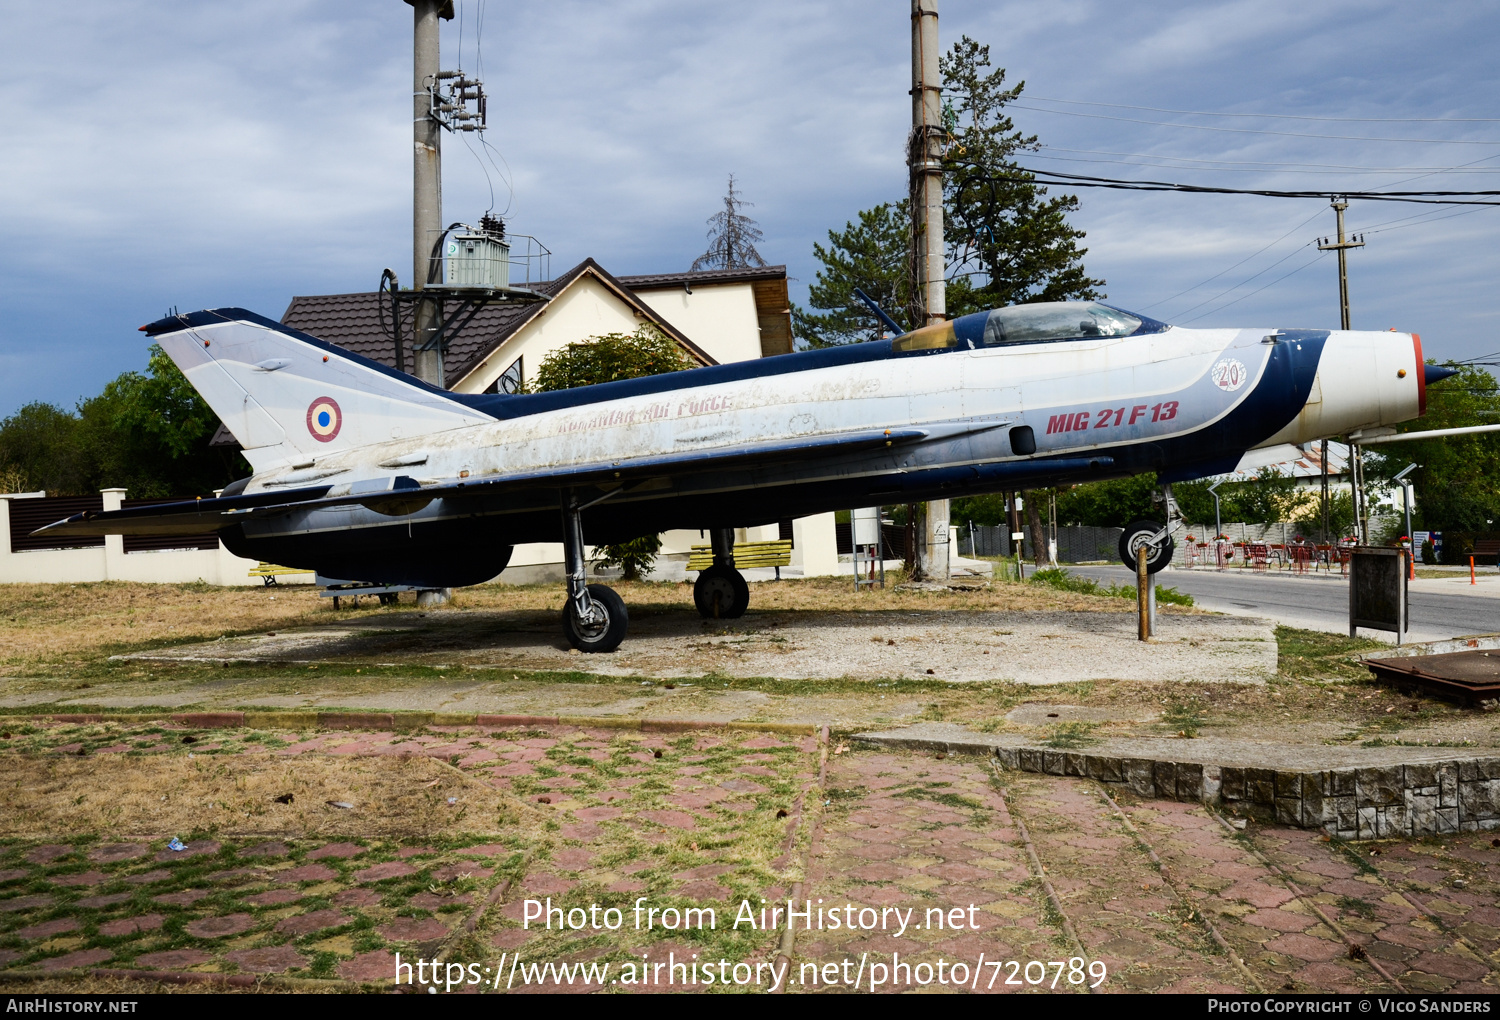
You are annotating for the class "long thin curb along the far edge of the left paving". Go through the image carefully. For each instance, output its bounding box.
[0,710,818,737]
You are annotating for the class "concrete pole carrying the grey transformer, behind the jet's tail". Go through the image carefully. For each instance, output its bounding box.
[407,0,453,389]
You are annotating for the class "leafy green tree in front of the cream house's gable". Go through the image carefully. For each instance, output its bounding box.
[531,324,693,581]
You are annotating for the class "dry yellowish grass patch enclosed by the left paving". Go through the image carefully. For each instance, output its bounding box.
[0,755,540,842]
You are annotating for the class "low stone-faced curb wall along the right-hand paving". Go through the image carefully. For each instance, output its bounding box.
[851,734,1500,840]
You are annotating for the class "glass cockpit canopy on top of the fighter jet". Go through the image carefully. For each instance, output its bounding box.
[893,302,1167,351]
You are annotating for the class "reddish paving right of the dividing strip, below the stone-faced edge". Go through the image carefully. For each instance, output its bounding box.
[798,752,1500,993]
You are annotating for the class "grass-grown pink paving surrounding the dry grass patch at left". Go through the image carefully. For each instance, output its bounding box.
[0,726,816,981]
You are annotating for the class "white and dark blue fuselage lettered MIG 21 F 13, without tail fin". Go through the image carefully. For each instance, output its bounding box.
[228,327,1421,579]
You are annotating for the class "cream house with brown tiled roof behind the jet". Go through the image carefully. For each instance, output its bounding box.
[282,258,839,584]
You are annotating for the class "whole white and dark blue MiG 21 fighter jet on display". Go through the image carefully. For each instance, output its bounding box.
[42,302,1451,651]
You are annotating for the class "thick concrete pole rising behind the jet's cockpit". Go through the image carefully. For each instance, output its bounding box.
[906,0,950,581]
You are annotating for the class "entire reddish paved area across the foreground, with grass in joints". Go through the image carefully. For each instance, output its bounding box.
[0,725,1500,993]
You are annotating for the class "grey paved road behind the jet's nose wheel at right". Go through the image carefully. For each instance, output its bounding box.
[1068,567,1500,641]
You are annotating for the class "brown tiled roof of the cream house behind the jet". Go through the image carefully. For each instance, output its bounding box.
[282,258,720,387]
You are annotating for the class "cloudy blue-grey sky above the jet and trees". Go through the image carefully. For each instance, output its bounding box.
[0,0,1500,414]
